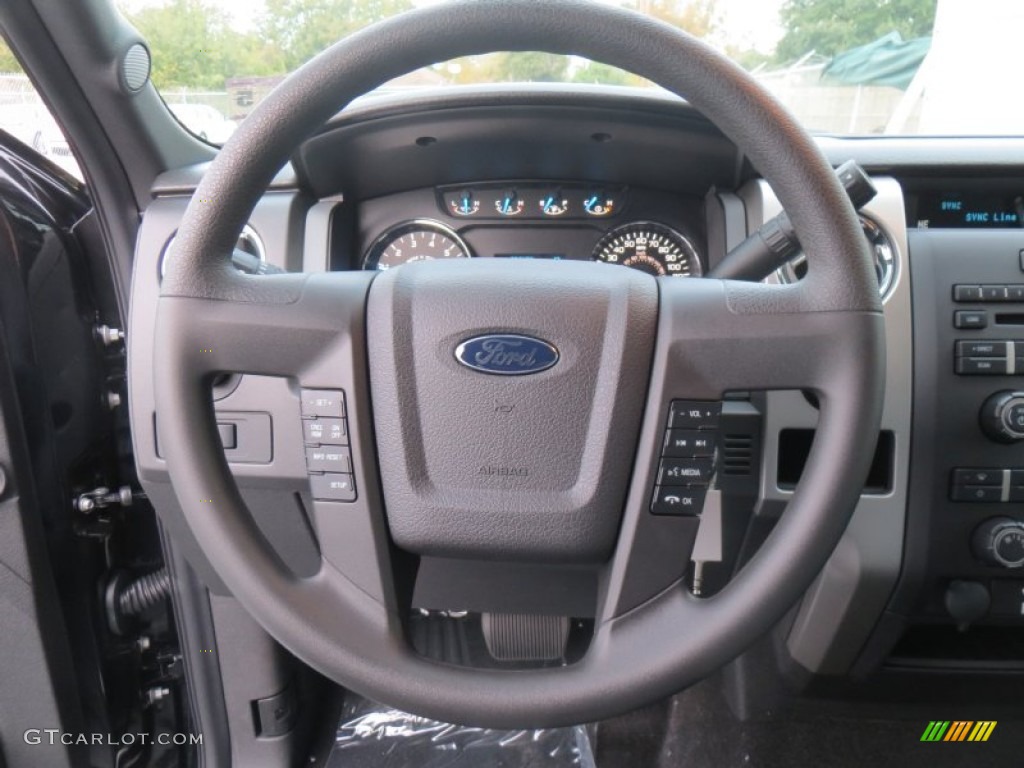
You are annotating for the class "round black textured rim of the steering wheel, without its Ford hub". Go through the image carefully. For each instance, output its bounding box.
[154,0,884,727]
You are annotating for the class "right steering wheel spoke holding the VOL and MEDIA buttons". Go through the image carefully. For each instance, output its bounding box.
[598,279,884,622]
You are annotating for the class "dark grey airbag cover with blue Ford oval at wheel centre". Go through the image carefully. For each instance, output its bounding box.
[367,259,657,562]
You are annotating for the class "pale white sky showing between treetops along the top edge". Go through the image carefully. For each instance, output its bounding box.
[118,0,783,52]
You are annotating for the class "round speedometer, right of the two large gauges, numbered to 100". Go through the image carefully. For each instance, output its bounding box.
[594,221,702,278]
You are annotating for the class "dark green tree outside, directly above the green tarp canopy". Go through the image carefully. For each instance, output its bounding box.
[775,0,937,62]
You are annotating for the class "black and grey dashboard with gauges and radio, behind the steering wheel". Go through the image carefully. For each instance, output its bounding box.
[130,86,1024,708]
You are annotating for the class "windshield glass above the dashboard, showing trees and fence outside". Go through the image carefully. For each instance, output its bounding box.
[112,0,1024,143]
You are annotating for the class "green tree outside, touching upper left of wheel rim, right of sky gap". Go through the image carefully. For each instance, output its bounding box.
[260,0,413,71]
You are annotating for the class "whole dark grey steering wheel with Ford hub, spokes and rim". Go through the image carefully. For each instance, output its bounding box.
[154,0,885,727]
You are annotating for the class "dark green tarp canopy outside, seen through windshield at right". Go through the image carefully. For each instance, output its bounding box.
[821,32,932,90]
